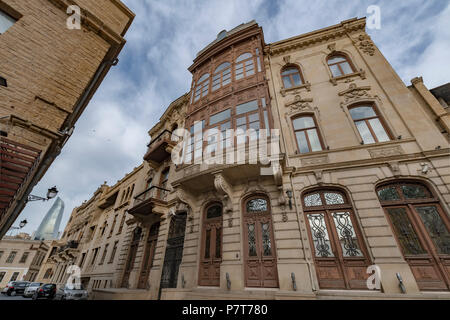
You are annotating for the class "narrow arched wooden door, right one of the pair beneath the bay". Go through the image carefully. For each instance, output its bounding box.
[243,197,278,288]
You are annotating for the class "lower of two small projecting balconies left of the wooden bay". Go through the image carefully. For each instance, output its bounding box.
[128,186,169,221]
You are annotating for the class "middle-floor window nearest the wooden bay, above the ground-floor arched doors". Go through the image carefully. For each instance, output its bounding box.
[292,115,323,153]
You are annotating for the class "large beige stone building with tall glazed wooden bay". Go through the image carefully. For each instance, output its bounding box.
[36,19,450,299]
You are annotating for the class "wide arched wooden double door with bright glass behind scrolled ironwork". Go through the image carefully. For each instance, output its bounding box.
[303,189,370,289]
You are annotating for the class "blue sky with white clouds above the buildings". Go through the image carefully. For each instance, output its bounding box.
[12,0,450,238]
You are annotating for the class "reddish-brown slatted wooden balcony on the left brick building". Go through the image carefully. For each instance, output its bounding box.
[0,137,41,218]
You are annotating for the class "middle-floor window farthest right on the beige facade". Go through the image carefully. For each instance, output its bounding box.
[349,105,391,144]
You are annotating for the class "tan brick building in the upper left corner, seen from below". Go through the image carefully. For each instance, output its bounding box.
[0,0,134,238]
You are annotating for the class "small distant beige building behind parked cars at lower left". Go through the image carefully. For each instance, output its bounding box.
[0,236,49,289]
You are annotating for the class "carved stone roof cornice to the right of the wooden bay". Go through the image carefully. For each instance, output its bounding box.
[264,18,366,56]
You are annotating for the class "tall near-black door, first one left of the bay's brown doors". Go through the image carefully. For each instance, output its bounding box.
[160,213,187,294]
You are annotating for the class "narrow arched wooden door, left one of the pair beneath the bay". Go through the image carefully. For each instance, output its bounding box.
[199,204,223,286]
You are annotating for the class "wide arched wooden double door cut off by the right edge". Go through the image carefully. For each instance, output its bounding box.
[377,181,450,290]
